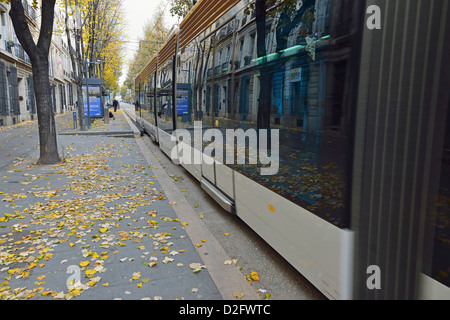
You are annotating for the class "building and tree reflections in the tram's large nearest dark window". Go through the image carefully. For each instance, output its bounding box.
[169,0,354,228]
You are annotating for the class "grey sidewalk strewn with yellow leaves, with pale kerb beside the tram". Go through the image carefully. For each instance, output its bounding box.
[0,110,259,300]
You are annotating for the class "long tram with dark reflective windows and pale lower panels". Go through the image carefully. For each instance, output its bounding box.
[135,0,450,299]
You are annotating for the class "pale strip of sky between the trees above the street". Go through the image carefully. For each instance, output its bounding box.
[119,0,177,85]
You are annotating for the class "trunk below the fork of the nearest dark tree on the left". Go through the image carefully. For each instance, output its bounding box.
[33,60,61,165]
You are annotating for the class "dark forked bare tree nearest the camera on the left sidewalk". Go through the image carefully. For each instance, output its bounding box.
[3,0,61,165]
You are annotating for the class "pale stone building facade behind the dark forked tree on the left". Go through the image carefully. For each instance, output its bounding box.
[0,0,76,126]
